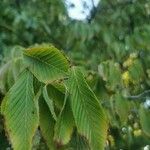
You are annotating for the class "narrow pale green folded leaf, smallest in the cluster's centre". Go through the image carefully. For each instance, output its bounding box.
[43,86,57,120]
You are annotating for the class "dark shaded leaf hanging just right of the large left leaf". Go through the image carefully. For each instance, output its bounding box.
[39,98,55,150]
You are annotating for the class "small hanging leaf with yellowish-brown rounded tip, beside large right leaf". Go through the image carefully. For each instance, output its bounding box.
[54,89,74,145]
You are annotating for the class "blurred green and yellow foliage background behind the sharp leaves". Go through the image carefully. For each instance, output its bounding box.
[0,0,150,150]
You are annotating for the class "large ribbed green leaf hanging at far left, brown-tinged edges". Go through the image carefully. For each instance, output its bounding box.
[2,70,38,150]
